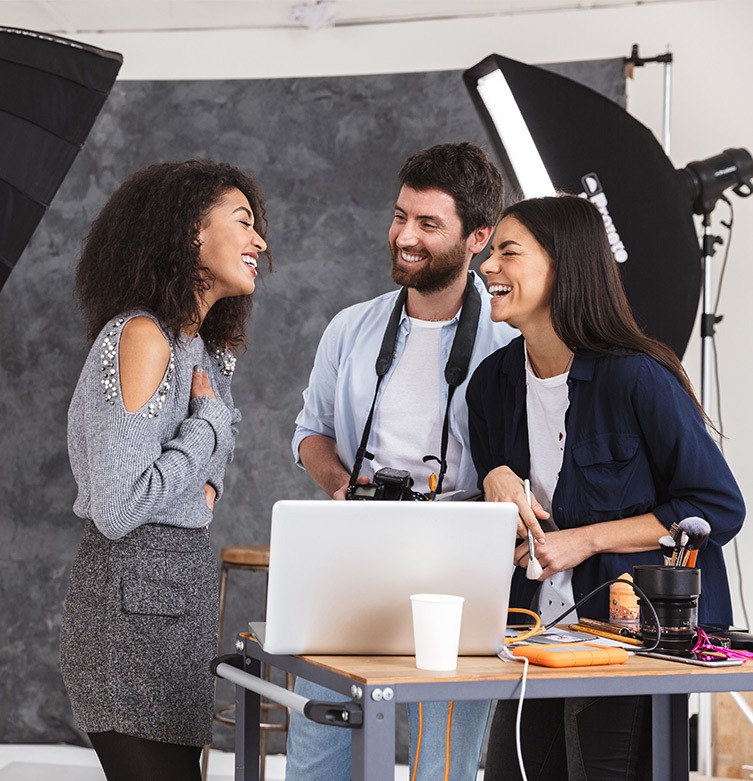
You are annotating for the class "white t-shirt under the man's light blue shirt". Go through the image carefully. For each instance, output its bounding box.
[369,317,461,493]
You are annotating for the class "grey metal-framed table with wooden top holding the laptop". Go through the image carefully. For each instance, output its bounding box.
[222,634,753,781]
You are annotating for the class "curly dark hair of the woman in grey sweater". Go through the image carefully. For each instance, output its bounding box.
[75,160,272,348]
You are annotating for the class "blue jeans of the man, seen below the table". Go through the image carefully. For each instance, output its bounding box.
[285,678,491,781]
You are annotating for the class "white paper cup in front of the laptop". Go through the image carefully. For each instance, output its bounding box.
[410,594,465,671]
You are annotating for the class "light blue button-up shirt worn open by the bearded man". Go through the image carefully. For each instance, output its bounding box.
[292,274,517,498]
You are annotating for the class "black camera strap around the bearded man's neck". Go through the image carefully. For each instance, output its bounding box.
[350,272,481,494]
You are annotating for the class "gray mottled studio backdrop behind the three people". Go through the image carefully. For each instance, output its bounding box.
[0,60,625,758]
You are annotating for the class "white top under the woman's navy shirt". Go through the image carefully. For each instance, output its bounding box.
[526,350,578,624]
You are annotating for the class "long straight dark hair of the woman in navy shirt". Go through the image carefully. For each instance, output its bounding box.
[502,194,710,423]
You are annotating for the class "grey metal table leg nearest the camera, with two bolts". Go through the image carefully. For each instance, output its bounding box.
[351,686,395,781]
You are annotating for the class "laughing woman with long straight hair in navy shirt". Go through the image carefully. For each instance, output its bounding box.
[467,195,745,781]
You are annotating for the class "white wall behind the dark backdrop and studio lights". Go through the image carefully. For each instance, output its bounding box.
[78,0,753,624]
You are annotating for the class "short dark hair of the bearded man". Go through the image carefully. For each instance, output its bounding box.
[398,141,504,236]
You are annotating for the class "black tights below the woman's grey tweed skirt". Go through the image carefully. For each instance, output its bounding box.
[89,732,201,781]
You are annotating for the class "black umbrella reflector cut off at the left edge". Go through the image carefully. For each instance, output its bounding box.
[0,27,123,288]
